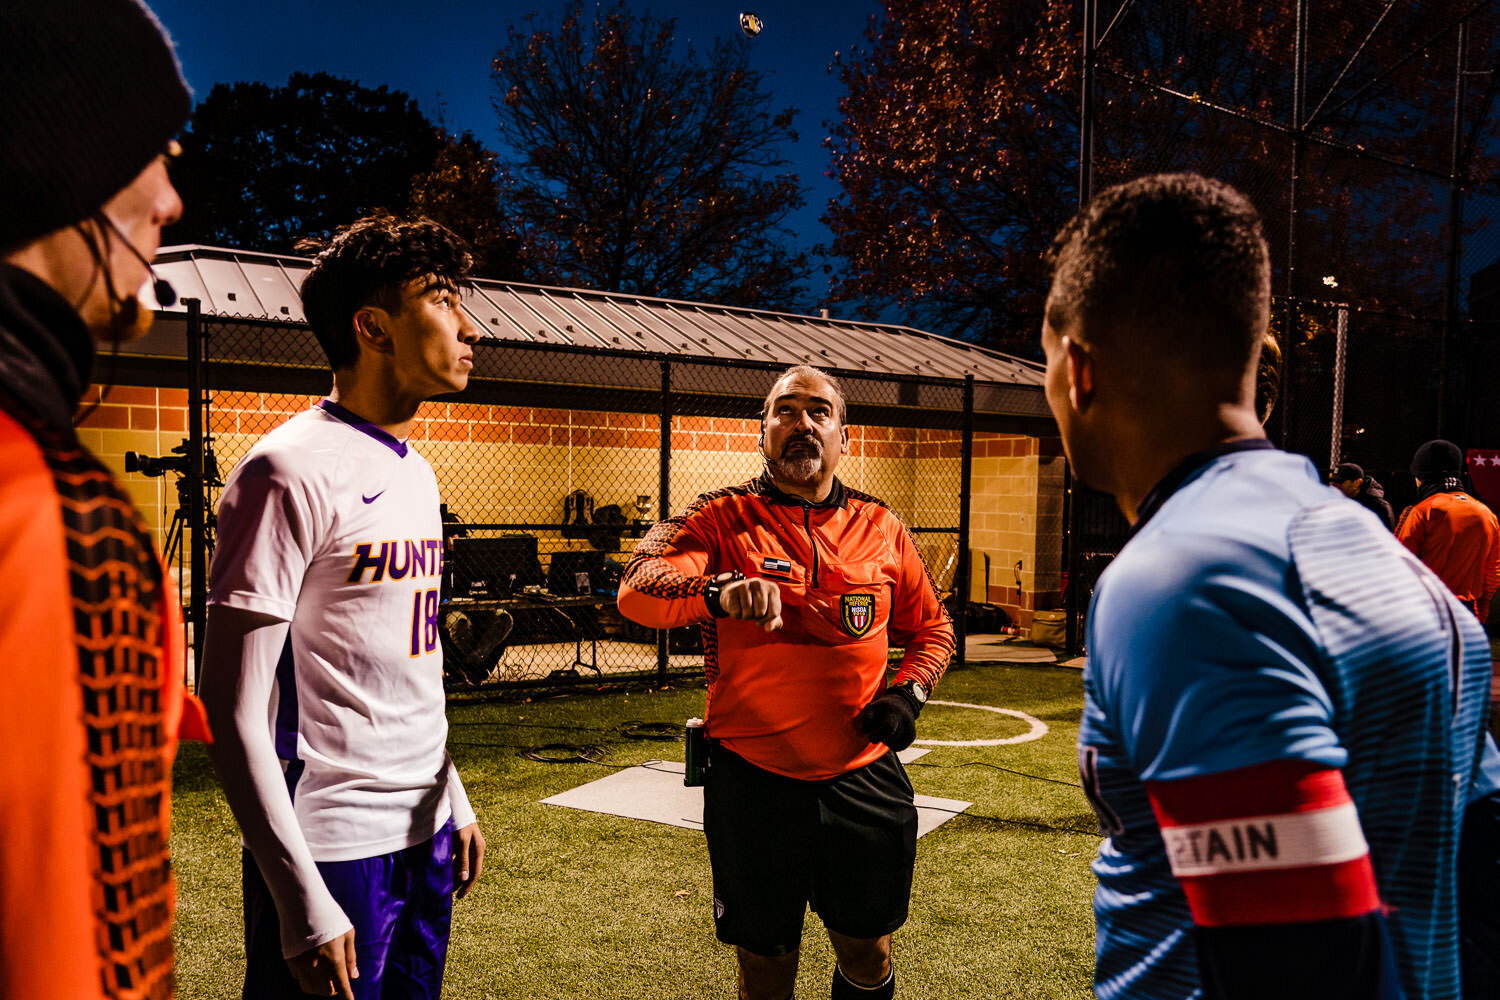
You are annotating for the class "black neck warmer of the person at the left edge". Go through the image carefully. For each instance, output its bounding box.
[0,264,95,432]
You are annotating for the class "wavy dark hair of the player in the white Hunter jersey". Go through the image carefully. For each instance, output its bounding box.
[297,211,474,372]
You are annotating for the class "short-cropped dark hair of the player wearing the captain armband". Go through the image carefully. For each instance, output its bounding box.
[1047,174,1271,376]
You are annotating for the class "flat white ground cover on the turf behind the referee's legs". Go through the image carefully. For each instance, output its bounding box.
[542,748,974,837]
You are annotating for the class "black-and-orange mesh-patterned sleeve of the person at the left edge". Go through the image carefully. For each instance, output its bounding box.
[38,431,174,1000]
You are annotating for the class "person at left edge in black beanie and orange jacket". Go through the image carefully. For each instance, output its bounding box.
[0,0,207,1000]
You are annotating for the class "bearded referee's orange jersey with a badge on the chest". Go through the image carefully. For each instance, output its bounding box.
[620,475,954,780]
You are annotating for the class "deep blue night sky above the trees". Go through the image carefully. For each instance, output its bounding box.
[149,0,881,297]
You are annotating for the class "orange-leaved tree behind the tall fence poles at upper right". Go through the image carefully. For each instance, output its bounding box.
[824,0,1496,352]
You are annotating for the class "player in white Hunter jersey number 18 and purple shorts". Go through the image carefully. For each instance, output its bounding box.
[201,214,485,1000]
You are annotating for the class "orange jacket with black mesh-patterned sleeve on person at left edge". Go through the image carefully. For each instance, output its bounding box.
[0,265,207,1000]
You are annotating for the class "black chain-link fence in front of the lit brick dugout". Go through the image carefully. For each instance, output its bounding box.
[189,318,984,691]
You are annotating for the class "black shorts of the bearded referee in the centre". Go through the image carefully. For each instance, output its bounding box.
[704,745,917,955]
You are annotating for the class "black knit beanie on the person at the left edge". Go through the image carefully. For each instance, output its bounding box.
[0,0,191,250]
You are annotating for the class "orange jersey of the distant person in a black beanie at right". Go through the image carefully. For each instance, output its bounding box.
[1397,492,1500,621]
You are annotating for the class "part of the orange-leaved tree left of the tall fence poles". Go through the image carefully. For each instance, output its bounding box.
[824,0,1079,352]
